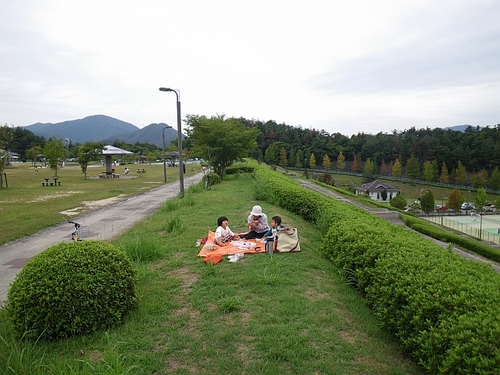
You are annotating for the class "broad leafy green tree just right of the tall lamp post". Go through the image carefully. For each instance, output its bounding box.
[186,115,260,179]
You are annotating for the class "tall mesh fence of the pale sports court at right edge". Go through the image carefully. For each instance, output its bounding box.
[423,215,500,245]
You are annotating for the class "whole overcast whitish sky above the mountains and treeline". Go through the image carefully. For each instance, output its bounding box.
[0,0,500,136]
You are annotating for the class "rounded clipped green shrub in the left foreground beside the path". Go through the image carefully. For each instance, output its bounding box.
[7,241,140,339]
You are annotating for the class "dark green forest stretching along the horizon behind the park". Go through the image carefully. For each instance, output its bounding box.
[0,118,500,190]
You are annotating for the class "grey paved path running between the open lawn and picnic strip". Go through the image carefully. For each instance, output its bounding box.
[0,173,203,306]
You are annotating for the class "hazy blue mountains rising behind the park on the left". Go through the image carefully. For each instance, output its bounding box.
[25,115,184,147]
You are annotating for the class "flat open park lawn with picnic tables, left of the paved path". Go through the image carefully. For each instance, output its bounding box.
[0,163,201,244]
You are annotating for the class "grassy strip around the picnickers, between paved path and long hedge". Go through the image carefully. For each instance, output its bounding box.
[0,175,422,375]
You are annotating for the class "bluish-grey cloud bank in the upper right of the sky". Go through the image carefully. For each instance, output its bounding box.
[313,2,500,94]
